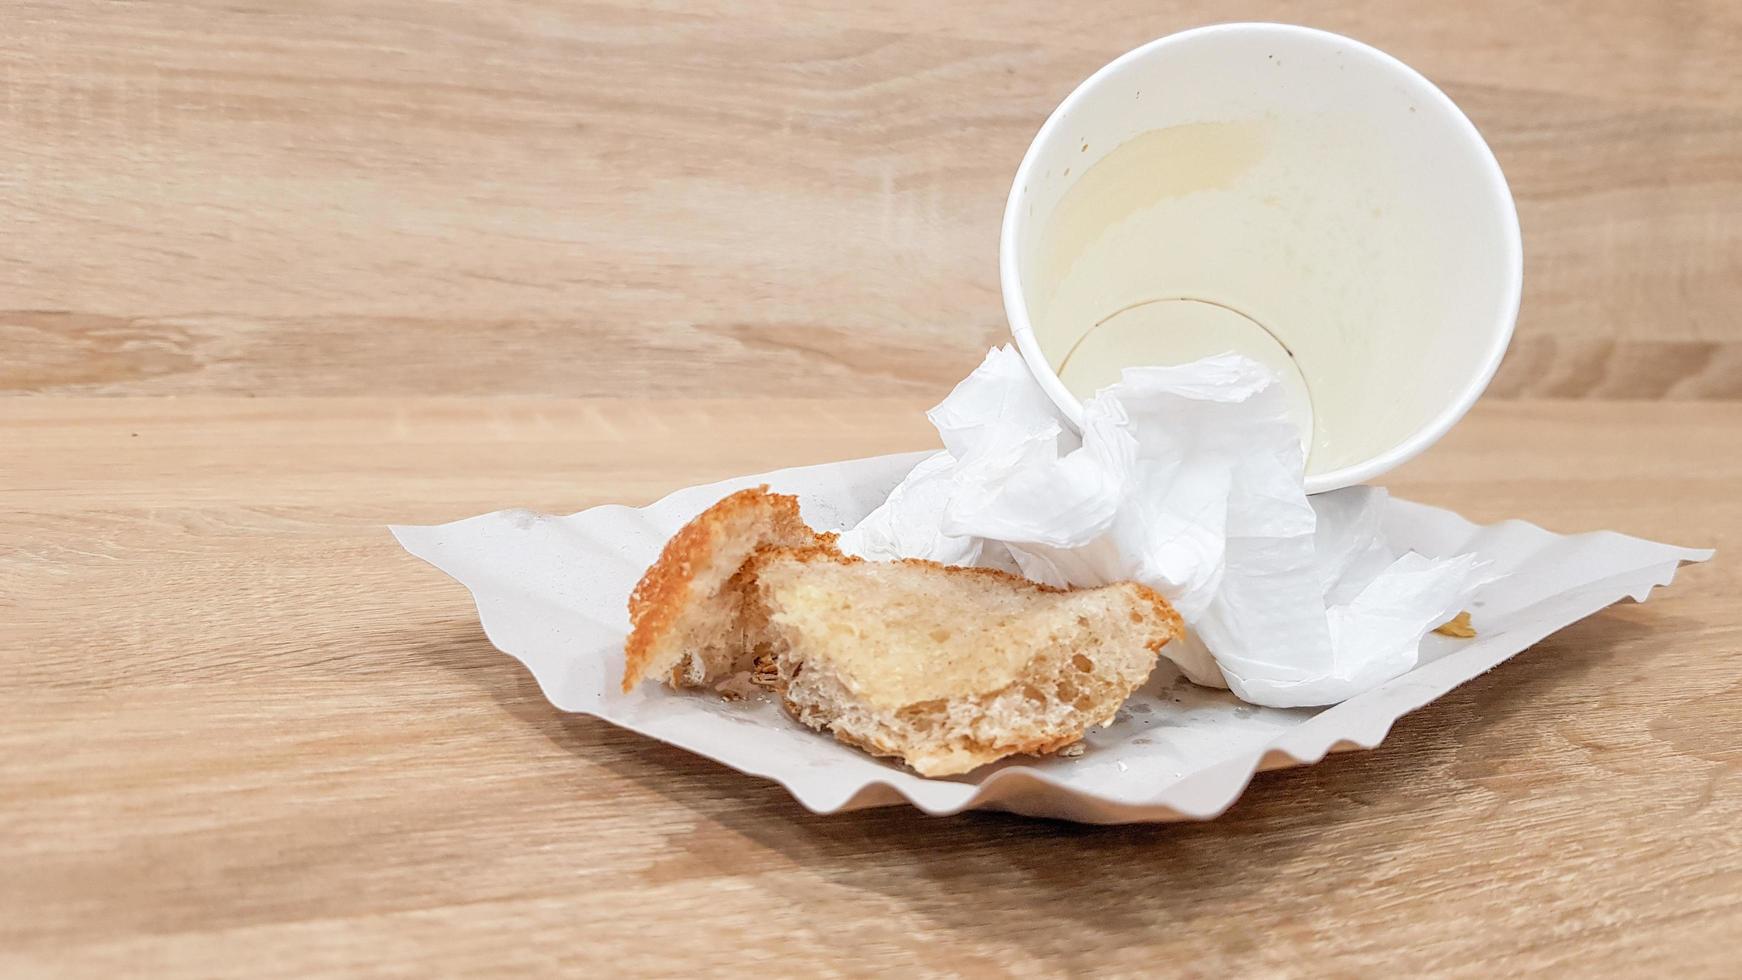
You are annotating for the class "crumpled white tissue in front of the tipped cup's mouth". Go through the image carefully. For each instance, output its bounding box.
[841,346,1489,707]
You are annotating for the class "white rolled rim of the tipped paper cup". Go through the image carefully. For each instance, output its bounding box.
[998,21,1524,493]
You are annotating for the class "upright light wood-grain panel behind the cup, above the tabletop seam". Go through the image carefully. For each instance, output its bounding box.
[0,0,1742,399]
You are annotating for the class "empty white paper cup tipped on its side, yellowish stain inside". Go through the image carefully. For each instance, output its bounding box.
[998,24,1524,493]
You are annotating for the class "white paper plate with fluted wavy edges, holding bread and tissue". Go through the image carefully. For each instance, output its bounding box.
[394,453,1711,823]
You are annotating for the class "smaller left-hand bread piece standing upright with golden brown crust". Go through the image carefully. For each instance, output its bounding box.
[624,486,834,693]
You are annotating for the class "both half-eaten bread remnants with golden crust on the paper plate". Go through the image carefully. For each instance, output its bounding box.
[624,491,1181,776]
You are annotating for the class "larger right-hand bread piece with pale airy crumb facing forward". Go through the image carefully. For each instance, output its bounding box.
[746,548,1181,776]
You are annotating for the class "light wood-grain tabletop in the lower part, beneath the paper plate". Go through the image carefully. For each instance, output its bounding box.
[0,397,1742,975]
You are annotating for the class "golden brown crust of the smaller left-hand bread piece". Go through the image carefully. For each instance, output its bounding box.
[624,486,818,693]
